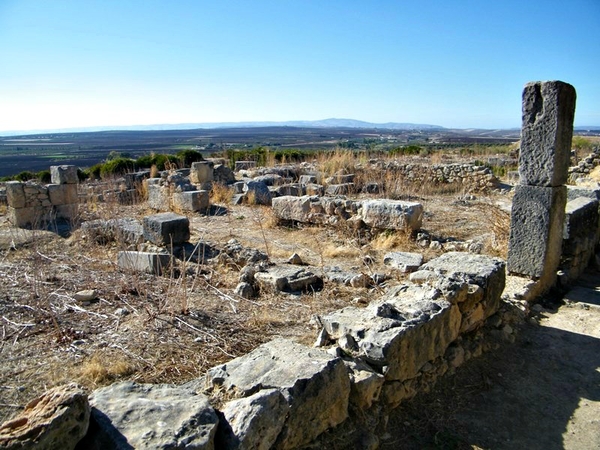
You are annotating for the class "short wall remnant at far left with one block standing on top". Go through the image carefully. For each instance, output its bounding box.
[6,166,79,228]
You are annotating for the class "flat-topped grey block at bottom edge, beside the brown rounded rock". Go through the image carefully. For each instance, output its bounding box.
[88,381,219,450]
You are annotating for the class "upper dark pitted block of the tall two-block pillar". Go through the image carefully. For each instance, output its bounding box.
[519,81,577,187]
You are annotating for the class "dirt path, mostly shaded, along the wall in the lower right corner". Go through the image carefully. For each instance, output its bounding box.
[381,273,600,450]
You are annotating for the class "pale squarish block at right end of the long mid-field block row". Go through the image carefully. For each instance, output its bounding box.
[358,199,423,231]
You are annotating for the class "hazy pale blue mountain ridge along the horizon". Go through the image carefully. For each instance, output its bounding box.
[0,119,444,136]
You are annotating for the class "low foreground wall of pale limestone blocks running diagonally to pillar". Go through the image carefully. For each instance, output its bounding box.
[68,252,505,449]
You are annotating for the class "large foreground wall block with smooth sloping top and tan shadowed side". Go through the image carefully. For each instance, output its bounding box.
[206,339,350,449]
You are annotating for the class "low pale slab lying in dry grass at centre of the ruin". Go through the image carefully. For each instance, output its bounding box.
[254,266,323,292]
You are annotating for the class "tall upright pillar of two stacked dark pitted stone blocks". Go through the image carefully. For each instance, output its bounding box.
[507,81,576,292]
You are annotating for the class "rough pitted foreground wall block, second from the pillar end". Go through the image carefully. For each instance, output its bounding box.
[322,285,461,381]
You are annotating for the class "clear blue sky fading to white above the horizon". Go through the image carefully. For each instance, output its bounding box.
[0,0,600,134]
